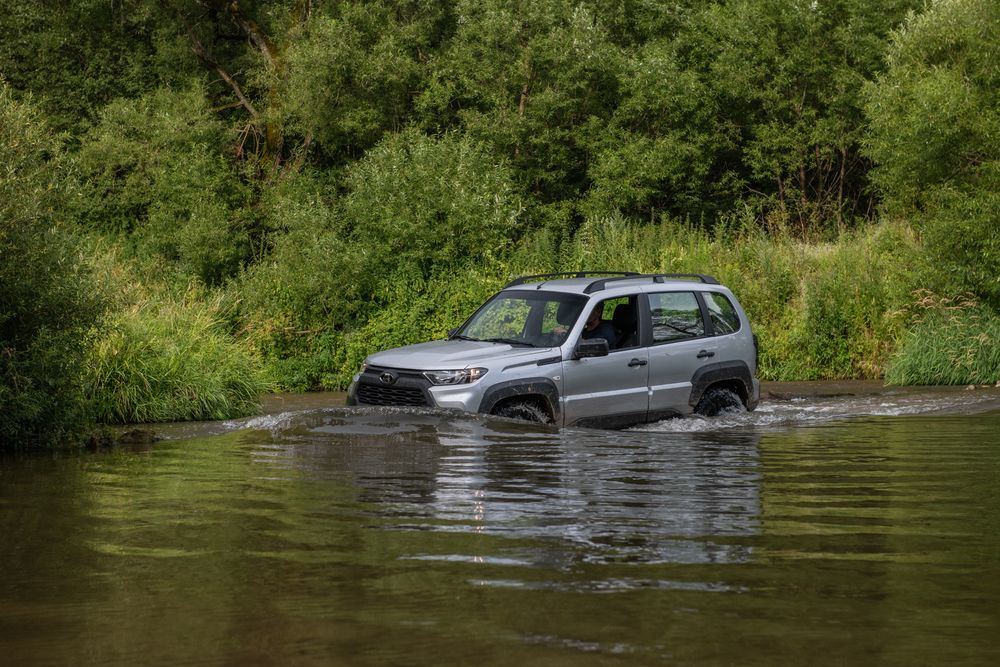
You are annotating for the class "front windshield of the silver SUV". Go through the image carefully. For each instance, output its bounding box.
[454,290,587,347]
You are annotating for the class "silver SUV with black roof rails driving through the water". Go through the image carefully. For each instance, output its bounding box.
[348,271,760,428]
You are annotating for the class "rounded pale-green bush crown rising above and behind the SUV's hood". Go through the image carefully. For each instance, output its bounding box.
[342,130,523,278]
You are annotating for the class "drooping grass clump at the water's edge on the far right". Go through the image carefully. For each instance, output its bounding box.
[885,291,1000,385]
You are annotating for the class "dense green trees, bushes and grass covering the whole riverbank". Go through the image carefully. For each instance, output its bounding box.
[0,0,1000,449]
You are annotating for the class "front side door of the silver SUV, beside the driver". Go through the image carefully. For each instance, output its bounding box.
[563,295,649,428]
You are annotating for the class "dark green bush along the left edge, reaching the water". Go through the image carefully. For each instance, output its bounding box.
[0,80,104,448]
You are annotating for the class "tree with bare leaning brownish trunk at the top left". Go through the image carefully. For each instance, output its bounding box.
[158,0,446,179]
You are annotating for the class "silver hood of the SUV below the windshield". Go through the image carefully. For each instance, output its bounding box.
[366,340,555,371]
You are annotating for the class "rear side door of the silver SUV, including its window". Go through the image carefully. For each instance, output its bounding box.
[648,291,716,420]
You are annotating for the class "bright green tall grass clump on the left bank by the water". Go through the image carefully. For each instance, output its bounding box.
[75,241,273,424]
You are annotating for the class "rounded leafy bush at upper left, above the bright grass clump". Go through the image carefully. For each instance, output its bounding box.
[73,88,254,285]
